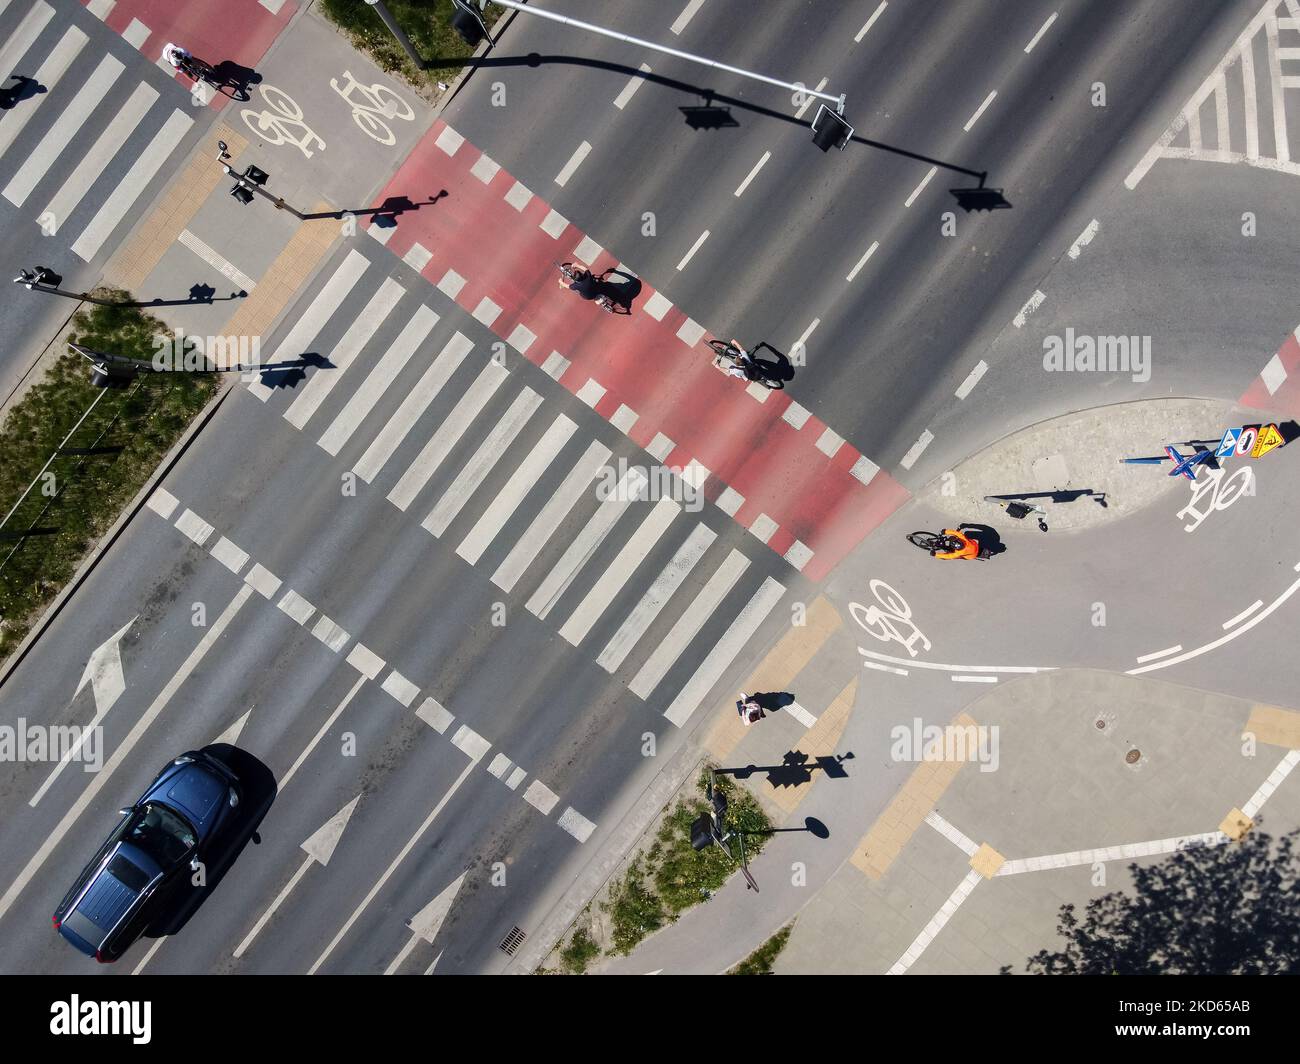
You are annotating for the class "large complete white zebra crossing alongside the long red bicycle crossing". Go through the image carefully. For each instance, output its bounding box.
[247,247,797,727]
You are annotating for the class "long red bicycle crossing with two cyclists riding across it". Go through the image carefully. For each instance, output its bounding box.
[371,121,907,580]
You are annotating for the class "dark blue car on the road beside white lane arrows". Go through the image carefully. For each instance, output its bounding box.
[55,751,239,963]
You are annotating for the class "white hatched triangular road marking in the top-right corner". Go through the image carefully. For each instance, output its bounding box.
[1125,0,1300,189]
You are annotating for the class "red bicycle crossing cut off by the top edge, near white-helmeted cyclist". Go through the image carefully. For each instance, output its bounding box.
[82,0,298,100]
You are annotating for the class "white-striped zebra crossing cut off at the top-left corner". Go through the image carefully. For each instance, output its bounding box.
[0,0,194,263]
